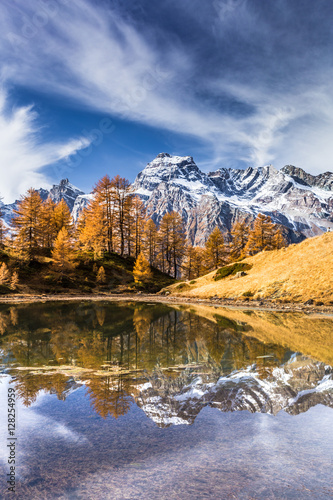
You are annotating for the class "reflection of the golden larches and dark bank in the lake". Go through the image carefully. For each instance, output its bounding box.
[0,302,325,418]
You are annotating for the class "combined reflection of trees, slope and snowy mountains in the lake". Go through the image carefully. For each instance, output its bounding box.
[0,302,333,427]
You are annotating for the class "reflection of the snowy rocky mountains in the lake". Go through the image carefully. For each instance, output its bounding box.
[135,355,333,427]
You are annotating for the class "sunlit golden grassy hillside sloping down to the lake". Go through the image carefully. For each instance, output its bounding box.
[164,233,333,304]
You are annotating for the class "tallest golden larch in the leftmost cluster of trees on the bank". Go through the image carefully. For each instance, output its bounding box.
[12,188,42,259]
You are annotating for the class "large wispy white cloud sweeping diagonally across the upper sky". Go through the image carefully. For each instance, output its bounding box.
[0,0,333,184]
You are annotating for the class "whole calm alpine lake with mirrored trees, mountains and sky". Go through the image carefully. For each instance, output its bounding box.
[0,301,333,500]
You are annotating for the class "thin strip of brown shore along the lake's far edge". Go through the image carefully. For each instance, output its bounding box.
[0,293,333,316]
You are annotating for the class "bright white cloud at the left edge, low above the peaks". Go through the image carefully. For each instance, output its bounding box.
[0,90,89,203]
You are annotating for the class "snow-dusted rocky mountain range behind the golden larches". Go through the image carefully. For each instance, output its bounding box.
[2,153,333,245]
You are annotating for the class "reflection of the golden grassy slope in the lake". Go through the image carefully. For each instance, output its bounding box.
[172,305,333,365]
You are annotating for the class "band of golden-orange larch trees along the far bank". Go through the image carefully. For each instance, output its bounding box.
[0,175,286,288]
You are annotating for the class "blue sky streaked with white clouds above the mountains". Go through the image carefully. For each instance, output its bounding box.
[0,0,333,202]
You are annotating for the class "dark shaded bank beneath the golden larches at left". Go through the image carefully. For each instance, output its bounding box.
[0,252,174,295]
